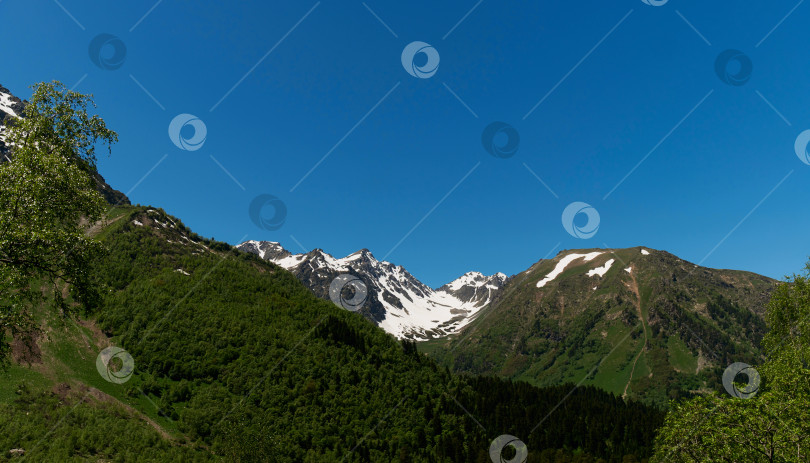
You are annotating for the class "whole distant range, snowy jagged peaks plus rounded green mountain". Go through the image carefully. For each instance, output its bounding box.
[237,241,777,404]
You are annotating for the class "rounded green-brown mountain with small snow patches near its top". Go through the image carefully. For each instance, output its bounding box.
[423,247,776,403]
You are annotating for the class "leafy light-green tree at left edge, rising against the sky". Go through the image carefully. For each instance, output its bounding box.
[0,82,117,366]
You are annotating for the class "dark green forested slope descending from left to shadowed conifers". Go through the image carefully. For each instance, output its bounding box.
[0,207,663,462]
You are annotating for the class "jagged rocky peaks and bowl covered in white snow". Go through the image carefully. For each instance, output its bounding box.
[237,241,506,340]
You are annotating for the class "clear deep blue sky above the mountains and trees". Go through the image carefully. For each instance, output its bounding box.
[0,0,810,286]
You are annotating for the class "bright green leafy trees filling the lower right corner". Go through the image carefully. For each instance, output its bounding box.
[654,264,810,462]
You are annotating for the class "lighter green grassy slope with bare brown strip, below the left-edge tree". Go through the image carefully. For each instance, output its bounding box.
[0,210,216,462]
